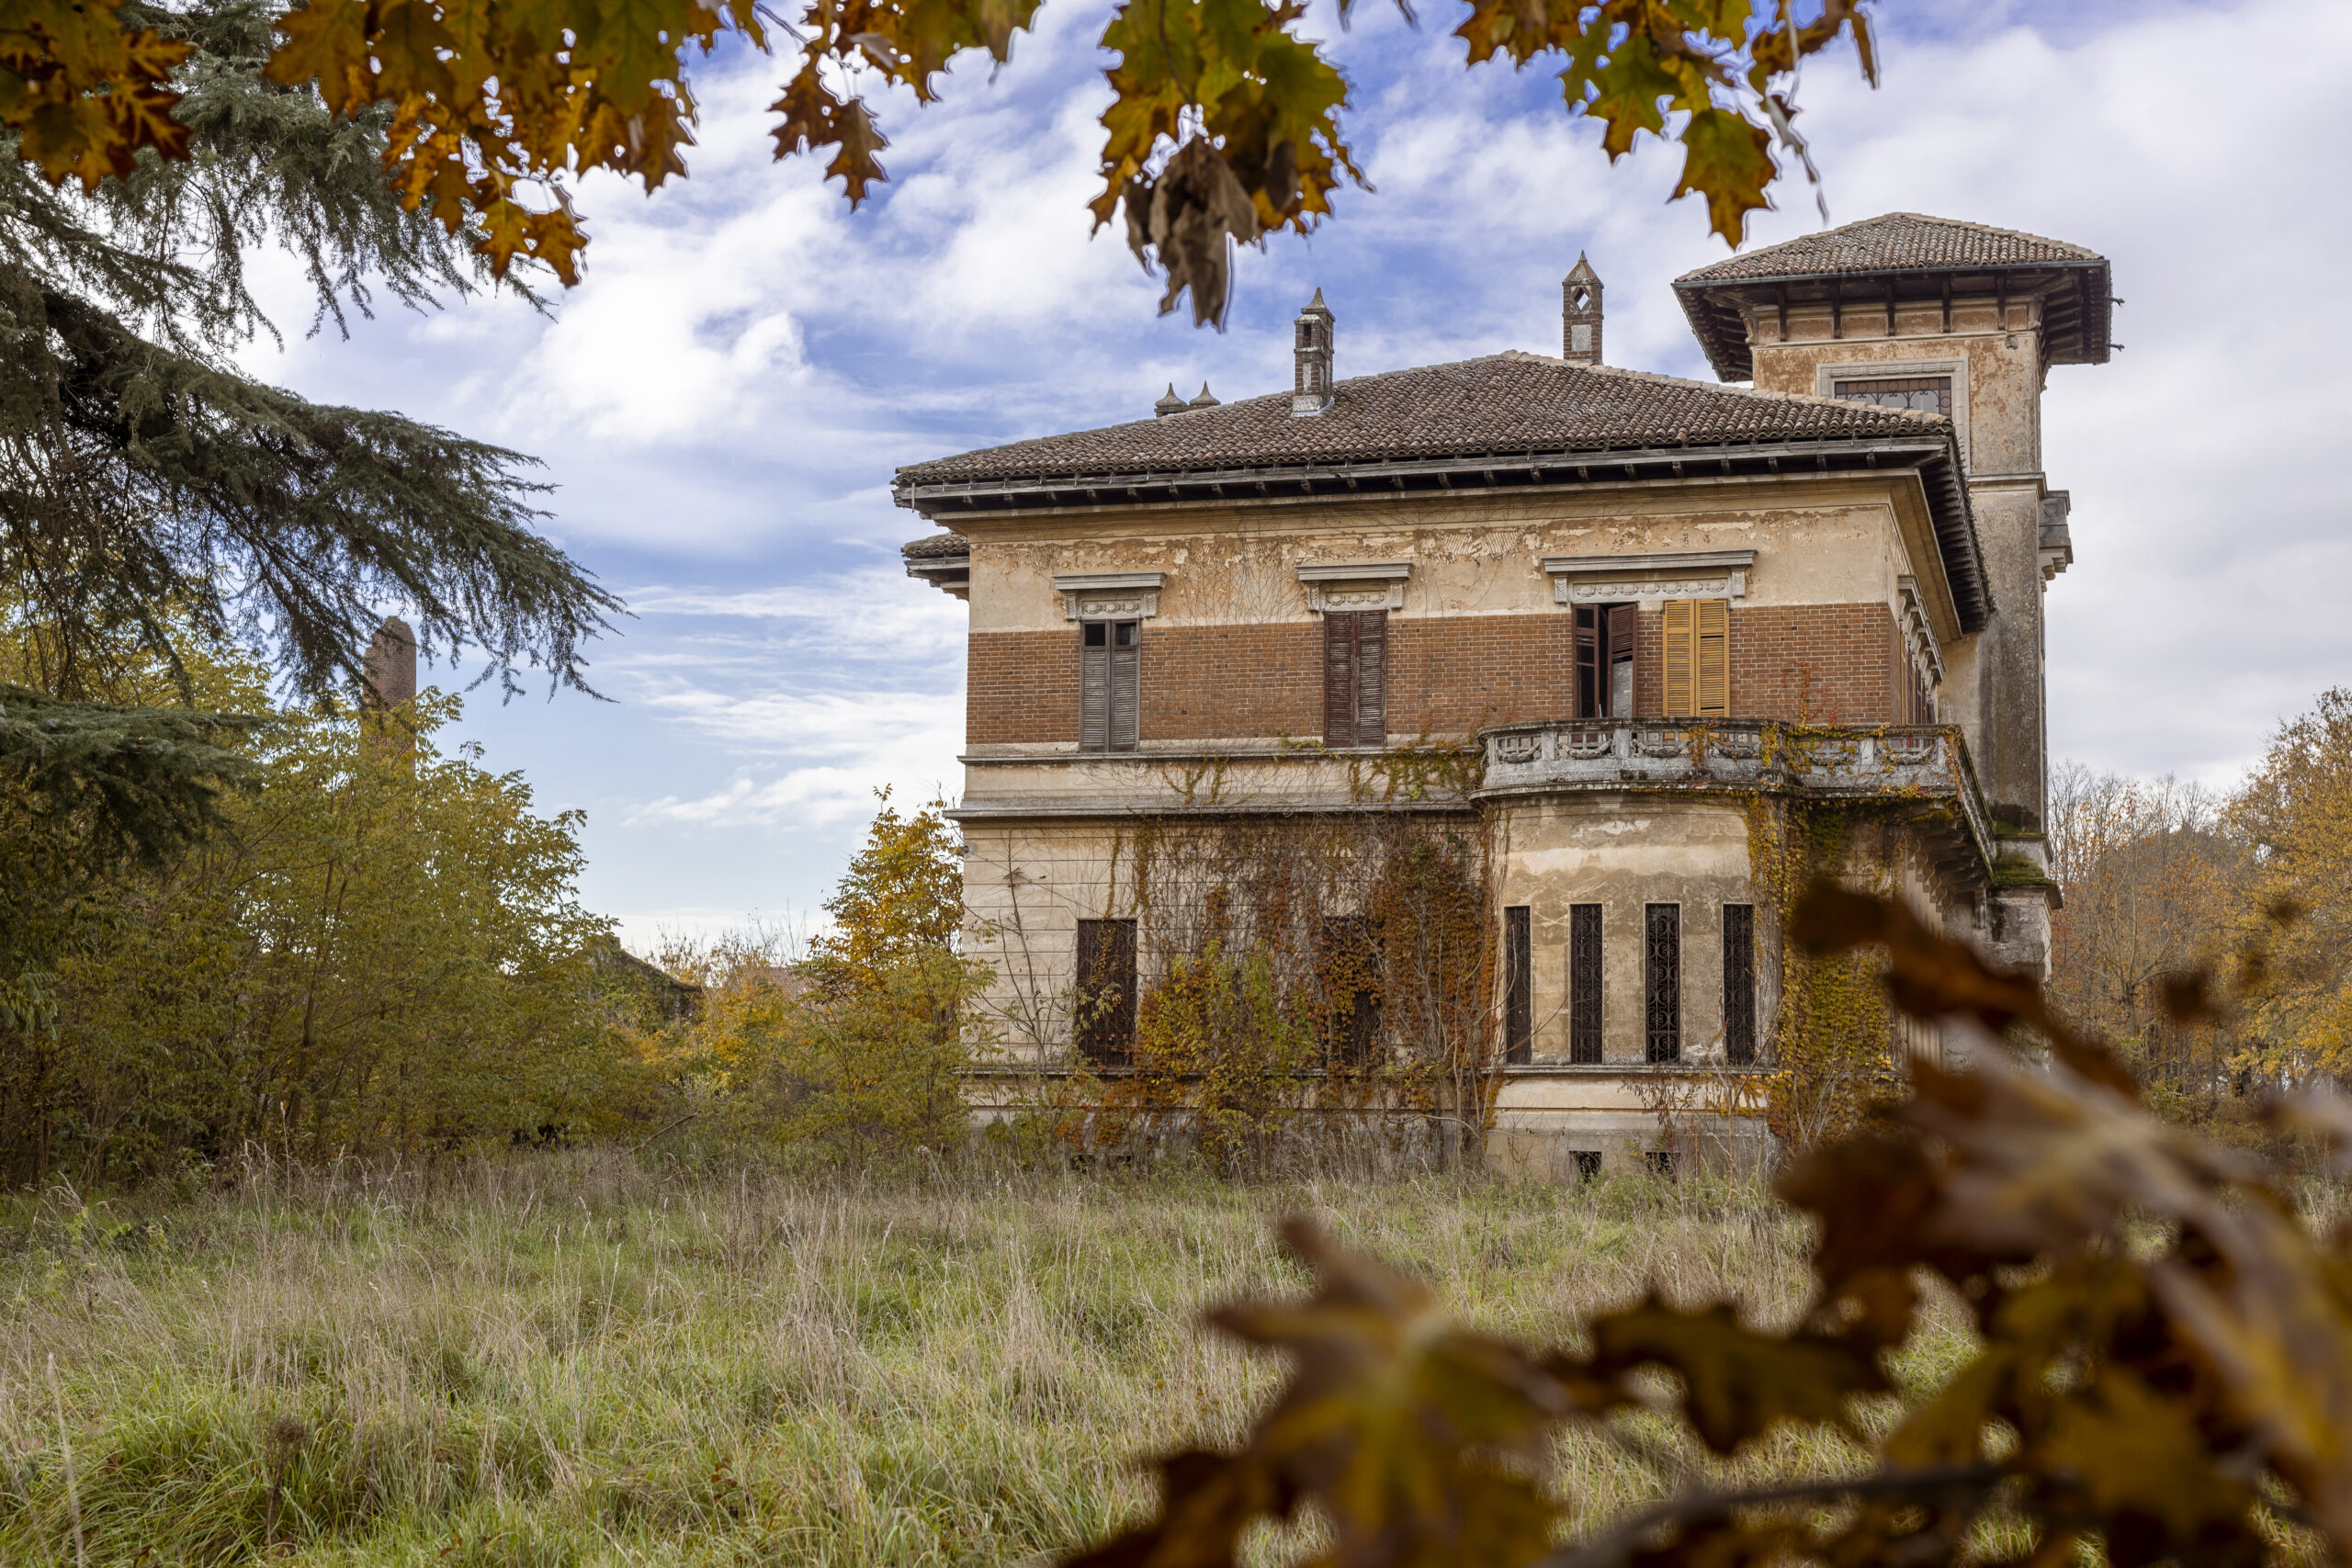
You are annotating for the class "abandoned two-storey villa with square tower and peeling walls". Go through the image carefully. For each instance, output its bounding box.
[896,214,2112,1178]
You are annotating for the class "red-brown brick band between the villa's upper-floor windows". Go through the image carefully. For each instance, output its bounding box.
[965,604,1907,745]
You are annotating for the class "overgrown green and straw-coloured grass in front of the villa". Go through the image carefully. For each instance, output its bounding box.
[0,1149,1962,1568]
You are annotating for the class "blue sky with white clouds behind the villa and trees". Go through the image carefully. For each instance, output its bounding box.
[233,0,2352,950]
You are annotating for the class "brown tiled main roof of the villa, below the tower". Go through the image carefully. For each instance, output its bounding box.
[899,353,1950,486]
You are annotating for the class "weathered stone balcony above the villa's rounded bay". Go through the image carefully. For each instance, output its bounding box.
[1475,719,1995,872]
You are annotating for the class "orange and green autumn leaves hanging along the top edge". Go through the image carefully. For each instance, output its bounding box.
[0,0,1877,322]
